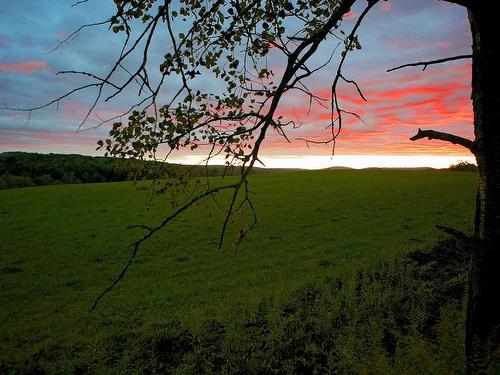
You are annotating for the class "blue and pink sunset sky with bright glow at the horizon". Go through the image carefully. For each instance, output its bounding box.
[0,0,473,169]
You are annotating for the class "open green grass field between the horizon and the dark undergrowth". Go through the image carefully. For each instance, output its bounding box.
[0,170,476,372]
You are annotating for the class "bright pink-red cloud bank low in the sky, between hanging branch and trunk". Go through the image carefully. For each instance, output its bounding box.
[263,63,474,155]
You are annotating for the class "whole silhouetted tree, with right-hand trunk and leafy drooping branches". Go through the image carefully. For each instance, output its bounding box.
[2,0,500,373]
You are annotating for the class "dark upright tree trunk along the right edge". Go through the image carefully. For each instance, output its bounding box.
[466,1,500,374]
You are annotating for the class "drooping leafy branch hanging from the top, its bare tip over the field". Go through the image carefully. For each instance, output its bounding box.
[6,0,386,310]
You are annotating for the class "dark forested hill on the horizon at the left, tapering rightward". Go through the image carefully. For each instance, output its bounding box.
[0,151,296,189]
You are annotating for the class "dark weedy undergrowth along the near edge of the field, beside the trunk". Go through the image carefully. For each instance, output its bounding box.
[0,240,469,374]
